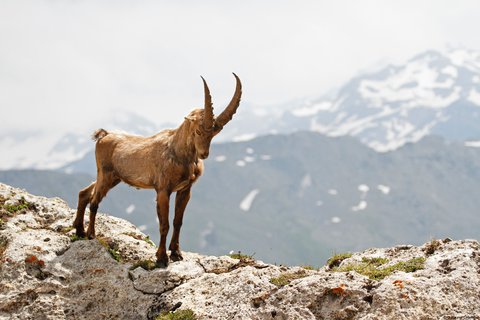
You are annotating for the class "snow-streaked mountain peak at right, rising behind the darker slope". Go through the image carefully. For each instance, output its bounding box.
[278,49,480,152]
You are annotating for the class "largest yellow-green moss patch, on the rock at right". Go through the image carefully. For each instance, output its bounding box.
[332,257,425,280]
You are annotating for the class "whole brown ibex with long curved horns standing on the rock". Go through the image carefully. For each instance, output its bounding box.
[73,74,242,267]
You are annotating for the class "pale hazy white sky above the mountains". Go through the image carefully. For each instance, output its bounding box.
[0,0,480,134]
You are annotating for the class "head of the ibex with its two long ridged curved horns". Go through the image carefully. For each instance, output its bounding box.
[185,73,242,159]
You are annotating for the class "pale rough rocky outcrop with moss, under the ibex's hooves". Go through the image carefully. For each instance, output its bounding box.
[0,184,480,319]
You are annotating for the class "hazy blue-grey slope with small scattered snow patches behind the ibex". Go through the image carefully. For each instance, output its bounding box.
[0,132,480,265]
